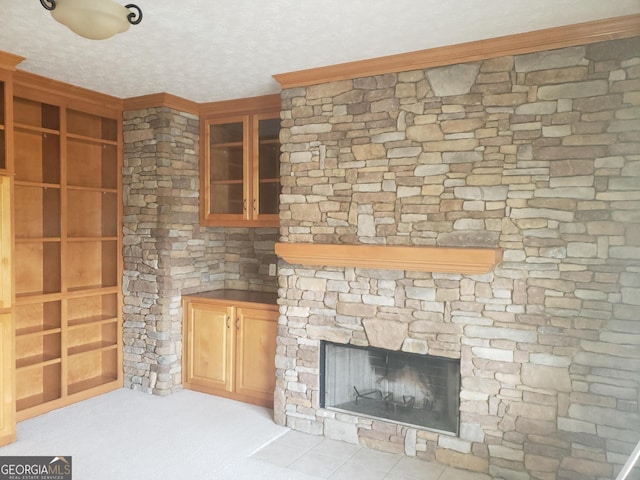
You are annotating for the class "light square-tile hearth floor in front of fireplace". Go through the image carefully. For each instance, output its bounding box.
[251,430,491,480]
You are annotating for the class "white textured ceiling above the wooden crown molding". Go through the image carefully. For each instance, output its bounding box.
[0,0,640,102]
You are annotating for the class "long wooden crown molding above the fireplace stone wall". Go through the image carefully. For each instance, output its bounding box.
[273,14,640,89]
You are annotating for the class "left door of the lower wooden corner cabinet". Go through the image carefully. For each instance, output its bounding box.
[184,302,234,392]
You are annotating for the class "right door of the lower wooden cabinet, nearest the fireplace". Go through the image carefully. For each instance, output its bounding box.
[236,308,278,406]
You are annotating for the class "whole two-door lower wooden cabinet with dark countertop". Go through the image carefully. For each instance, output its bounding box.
[182,290,278,407]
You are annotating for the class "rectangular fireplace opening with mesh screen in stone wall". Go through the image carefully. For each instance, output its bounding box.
[320,342,460,435]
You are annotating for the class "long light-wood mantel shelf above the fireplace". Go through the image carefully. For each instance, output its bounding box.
[275,243,502,274]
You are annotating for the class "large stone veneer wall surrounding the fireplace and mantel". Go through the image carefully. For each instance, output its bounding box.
[275,38,640,480]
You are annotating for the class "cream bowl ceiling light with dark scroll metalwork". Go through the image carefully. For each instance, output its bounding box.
[40,0,142,40]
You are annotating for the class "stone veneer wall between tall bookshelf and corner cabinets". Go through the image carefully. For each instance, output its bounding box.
[122,107,277,395]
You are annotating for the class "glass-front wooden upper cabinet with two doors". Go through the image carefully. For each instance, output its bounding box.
[200,103,280,227]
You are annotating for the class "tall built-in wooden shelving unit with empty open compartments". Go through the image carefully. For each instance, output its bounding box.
[13,88,122,420]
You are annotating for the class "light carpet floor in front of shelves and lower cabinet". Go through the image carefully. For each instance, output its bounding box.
[0,389,317,480]
